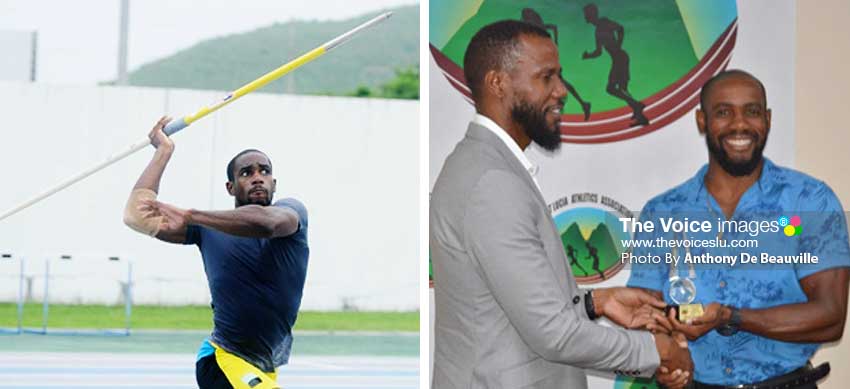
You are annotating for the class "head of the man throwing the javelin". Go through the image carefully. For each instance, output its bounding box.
[227,152,277,207]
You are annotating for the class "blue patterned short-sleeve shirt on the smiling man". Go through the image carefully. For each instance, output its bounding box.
[628,159,850,385]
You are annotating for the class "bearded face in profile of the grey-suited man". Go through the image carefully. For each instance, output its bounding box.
[510,35,567,150]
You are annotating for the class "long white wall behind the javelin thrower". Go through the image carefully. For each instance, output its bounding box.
[0,83,419,310]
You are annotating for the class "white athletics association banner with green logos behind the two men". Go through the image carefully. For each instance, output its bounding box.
[429,0,794,389]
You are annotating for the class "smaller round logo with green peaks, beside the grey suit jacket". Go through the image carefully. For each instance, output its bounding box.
[549,193,634,284]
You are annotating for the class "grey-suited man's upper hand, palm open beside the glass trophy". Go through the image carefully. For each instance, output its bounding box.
[592,287,673,333]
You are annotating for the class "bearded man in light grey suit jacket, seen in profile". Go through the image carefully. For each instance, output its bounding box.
[430,21,691,389]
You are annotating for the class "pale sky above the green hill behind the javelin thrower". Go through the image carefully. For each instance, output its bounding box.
[0,0,418,84]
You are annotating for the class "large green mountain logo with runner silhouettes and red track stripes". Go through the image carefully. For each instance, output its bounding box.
[429,0,738,143]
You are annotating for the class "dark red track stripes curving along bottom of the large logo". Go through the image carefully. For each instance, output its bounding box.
[429,18,737,144]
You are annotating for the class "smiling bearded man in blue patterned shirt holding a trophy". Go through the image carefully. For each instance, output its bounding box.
[628,70,850,388]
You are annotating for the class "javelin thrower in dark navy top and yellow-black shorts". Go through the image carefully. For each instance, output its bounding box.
[119,118,310,389]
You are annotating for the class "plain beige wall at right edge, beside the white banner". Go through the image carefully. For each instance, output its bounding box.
[794,0,850,389]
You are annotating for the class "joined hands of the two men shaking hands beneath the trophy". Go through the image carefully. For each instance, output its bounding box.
[592,287,696,388]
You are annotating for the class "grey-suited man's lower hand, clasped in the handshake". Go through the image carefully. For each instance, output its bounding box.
[654,333,694,389]
